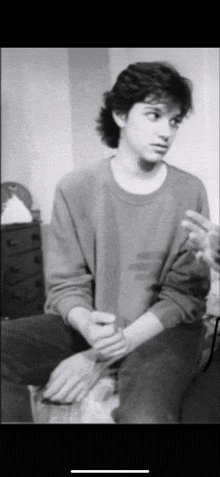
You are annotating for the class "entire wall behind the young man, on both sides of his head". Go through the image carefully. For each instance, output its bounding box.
[1,48,219,223]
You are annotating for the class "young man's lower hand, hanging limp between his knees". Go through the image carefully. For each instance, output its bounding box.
[43,349,100,404]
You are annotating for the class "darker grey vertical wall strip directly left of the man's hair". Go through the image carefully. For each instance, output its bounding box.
[67,48,111,169]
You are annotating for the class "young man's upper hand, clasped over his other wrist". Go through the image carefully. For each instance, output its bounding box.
[68,307,127,359]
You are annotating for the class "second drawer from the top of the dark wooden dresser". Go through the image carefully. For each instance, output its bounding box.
[3,249,43,286]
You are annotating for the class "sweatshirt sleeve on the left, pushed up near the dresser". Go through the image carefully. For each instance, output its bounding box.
[45,181,93,321]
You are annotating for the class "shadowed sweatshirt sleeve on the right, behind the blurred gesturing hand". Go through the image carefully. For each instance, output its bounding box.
[150,179,210,328]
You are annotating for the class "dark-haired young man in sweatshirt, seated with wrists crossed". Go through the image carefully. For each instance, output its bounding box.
[2,62,209,423]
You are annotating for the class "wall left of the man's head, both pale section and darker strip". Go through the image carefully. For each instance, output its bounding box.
[1,48,110,223]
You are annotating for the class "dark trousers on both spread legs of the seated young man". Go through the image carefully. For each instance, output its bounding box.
[1,315,204,424]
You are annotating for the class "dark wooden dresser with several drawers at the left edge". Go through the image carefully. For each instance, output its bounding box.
[1,221,45,320]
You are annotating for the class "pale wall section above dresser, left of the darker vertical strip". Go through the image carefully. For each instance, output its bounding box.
[1,48,74,223]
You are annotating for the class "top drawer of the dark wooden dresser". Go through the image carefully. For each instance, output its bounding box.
[2,224,41,256]
